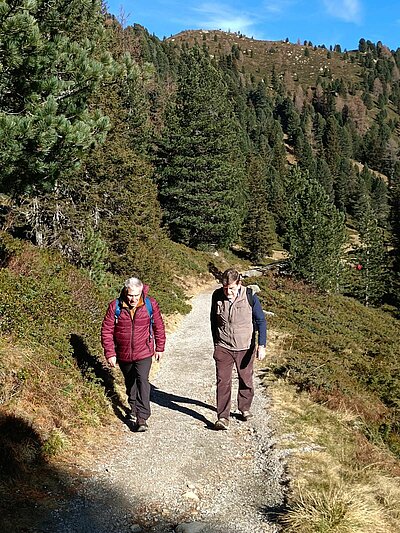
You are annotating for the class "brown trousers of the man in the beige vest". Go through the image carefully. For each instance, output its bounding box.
[214,346,255,418]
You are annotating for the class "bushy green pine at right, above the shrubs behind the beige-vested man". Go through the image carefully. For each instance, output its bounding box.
[287,169,346,290]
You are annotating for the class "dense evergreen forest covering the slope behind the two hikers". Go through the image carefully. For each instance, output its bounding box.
[0,0,400,307]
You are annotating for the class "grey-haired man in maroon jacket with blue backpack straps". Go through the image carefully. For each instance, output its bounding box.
[101,278,165,432]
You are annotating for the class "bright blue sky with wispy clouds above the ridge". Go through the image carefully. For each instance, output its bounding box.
[105,0,400,50]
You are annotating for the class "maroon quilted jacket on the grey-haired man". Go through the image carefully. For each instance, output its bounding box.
[101,285,165,363]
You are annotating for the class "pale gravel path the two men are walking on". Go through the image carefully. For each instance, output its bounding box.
[40,289,284,533]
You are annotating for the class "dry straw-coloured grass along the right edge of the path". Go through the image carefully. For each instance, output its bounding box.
[269,374,400,533]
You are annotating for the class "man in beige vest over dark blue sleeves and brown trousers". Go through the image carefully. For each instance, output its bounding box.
[210,269,267,430]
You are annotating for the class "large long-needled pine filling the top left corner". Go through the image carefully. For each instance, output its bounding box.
[0,0,112,193]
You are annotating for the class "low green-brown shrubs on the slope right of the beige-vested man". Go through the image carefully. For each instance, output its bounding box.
[257,277,400,454]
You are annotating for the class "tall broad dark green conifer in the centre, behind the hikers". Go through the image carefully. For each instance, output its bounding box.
[155,48,245,247]
